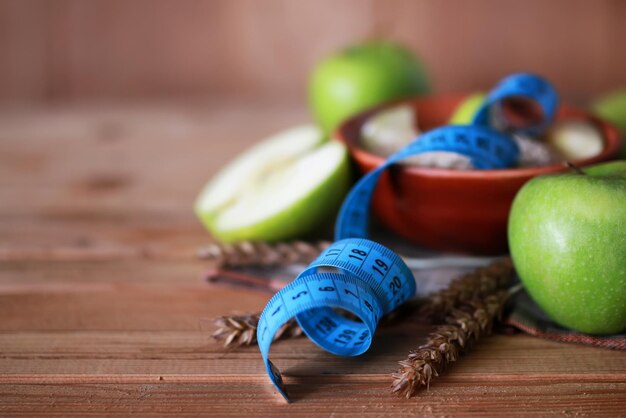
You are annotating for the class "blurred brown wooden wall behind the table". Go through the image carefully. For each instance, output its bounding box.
[0,0,626,102]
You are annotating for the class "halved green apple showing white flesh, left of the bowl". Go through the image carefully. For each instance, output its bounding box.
[195,125,350,242]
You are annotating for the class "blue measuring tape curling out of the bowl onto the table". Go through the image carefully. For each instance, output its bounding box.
[257,74,558,401]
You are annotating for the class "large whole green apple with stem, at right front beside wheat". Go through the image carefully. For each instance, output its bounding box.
[508,161,626,334]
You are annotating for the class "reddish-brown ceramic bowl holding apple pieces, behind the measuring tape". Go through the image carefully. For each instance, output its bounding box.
[335,95,620,254]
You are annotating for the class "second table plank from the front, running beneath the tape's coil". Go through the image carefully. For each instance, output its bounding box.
[0,330,626,378]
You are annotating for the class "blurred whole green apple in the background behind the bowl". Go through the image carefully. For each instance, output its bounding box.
[309,41,430,134]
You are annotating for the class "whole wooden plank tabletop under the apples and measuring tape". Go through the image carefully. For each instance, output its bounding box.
[0,103,626,416]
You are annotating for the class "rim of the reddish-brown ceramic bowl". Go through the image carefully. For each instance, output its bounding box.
[332,93,621,179]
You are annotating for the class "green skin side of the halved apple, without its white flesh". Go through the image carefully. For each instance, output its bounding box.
[196,143,352,243]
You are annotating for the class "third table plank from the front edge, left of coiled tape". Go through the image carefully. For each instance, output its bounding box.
[0,259,268,331]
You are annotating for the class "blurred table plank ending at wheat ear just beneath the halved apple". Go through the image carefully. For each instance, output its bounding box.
[0,214,204,262]
